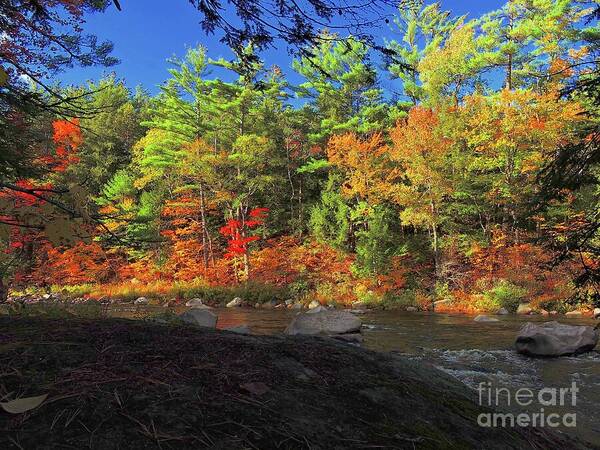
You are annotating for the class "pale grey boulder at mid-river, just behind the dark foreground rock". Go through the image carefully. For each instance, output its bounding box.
[284,309,362,335]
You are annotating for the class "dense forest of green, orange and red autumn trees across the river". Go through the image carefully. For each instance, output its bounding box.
[0,0,600,311]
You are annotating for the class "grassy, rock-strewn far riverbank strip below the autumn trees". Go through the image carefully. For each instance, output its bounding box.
[3,283,600,318]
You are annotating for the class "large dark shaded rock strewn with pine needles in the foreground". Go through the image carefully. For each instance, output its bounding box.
[0,318,586,449]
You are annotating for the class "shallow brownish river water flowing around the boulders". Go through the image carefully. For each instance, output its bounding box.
[111,307,600,445]
